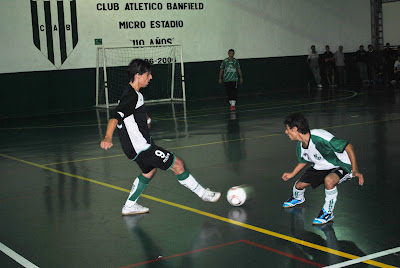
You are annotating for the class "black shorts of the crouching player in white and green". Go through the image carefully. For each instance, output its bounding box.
[299,167,352,189]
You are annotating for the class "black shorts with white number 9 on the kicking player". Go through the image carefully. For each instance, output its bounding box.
[134,145,175,174]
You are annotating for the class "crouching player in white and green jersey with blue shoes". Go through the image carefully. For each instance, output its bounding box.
[282,113,364,225]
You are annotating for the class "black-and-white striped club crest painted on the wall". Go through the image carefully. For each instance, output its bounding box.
[30,0,78,69]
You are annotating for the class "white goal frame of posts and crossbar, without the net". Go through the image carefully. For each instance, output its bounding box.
[95,44,186,109]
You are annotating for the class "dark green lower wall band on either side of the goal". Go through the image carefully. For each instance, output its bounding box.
[0,55,357,118]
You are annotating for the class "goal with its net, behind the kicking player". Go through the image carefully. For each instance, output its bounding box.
[96,45,186,108]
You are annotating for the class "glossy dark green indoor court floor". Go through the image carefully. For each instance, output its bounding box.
[0,87,400,267]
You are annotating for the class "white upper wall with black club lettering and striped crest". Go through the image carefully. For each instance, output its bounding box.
[0,0,371,73]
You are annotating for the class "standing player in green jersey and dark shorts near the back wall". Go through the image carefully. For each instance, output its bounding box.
[219,49,243,111]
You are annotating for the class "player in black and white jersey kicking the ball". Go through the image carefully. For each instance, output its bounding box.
[100,59,221,215]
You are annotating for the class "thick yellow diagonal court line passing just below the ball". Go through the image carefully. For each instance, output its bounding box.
[0,153,395,268]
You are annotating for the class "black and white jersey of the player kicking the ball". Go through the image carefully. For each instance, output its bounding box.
[114,85,151,160]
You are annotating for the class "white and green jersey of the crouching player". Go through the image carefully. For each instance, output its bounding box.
[296,129,352,173]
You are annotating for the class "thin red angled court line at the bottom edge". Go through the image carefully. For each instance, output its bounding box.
[120,239,325,268]
